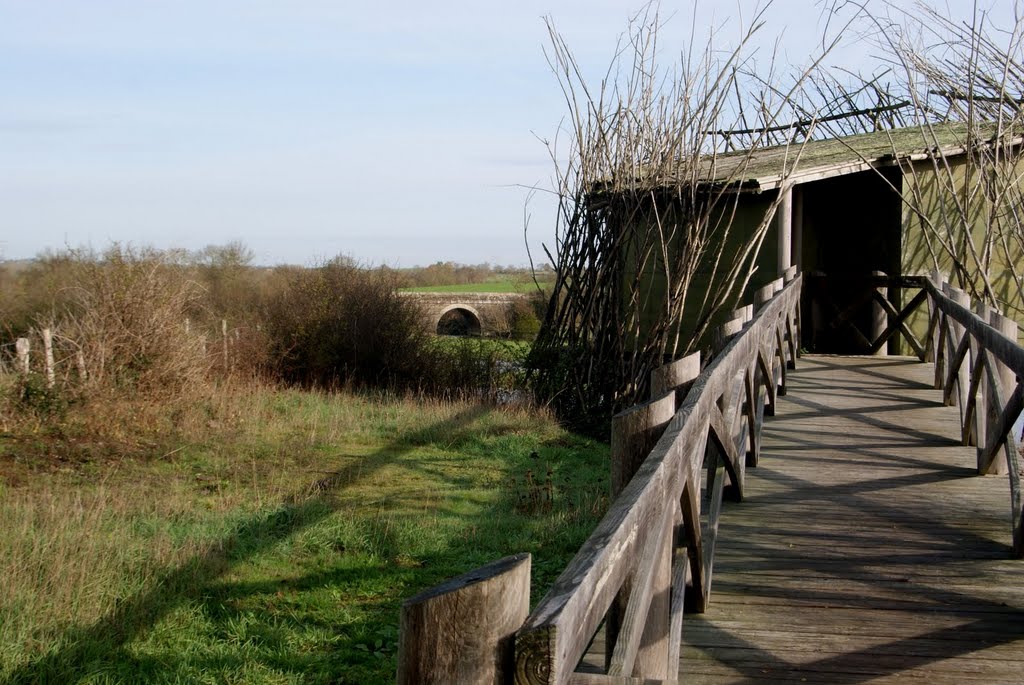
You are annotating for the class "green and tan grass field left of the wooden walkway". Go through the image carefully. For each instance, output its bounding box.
[0,387,607,683]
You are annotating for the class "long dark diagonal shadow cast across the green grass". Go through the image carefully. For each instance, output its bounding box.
[7,406,569,683]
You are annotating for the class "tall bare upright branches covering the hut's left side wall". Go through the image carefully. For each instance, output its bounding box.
[530,5,851,431]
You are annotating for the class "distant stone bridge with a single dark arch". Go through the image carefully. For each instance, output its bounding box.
[401,293,529,336]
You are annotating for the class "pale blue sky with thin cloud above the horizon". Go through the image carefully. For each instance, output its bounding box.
[0,0,995,266]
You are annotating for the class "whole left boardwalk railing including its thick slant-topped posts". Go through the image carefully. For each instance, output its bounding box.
[398,268,802,684]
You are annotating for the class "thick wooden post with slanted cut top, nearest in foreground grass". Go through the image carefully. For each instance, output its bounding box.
[398,554,530,685]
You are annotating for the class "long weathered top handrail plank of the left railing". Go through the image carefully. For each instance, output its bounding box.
[515,275,801,684]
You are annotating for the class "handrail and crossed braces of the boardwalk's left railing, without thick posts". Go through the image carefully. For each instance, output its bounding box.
[515,271,802,684]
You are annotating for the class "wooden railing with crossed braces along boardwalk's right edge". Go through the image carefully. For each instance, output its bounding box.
[925,274,1024,558]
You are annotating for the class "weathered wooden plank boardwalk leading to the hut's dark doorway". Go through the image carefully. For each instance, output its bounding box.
[680,356,1024,684]
